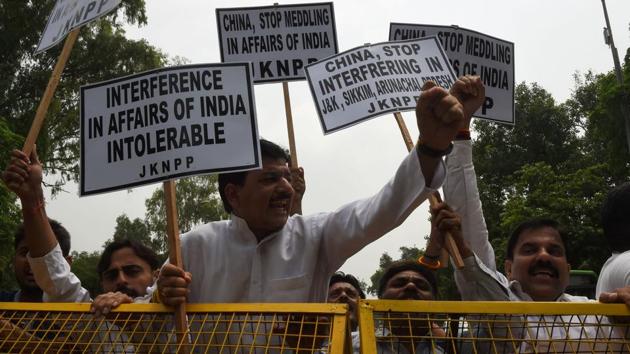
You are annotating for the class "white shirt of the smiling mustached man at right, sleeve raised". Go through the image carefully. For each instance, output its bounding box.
[444,141,619,352]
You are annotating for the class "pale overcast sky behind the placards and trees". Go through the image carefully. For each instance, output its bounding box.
[47,0,630,281]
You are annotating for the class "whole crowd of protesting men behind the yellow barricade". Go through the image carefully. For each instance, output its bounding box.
[0,76,630,353]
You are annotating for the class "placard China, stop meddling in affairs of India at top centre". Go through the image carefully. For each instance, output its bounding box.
[216,2,338,83]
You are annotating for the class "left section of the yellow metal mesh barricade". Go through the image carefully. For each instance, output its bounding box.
[0,303,348,354]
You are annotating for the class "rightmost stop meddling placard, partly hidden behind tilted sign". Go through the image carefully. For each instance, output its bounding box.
[389,23,514,124]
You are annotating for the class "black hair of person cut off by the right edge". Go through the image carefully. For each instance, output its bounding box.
[602,182,630,252]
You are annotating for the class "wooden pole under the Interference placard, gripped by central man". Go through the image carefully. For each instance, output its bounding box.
[164,181,188,351]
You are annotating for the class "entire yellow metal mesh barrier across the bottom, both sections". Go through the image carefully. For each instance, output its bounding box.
[0,300,630,354]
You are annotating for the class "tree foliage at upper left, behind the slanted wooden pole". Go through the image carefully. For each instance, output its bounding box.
[0,0,166,192]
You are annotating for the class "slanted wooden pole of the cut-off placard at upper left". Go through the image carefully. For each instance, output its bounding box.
[22,28,80,156]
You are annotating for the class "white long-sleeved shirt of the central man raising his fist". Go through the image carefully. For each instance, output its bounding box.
[170,149,444,303]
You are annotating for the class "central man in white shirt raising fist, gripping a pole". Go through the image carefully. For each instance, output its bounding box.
[154,77,484,305]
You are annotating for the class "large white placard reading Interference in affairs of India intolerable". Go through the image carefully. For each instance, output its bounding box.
[80,63,261,195]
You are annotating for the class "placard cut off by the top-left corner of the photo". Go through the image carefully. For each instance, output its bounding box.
[35,0,120,54]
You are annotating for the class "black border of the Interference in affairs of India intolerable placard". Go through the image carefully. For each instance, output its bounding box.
[79,63,260,197]
